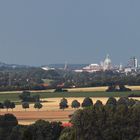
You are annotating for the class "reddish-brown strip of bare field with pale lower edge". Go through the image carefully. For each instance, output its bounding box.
[0,110,74,125]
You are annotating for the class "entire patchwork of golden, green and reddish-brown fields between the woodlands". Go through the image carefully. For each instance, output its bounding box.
[0,86,140,124]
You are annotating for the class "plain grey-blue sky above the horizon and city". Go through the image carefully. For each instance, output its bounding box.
[0,0,140,66]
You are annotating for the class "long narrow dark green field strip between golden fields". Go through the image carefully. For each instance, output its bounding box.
[0,91,140,102]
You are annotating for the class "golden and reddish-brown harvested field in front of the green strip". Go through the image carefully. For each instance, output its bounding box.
[0,97,140,124]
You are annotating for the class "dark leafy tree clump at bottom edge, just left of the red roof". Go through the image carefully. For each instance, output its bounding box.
[23,120,62,140]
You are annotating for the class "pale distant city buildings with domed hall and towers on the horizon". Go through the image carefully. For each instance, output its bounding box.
[42,55,140,74]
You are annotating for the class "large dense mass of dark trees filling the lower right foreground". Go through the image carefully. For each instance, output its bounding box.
[59,97,140,140]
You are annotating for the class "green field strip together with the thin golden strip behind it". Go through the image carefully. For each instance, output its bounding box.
[0,86,140,102]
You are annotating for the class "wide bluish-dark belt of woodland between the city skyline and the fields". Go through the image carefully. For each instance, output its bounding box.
[0,67,140,91]
